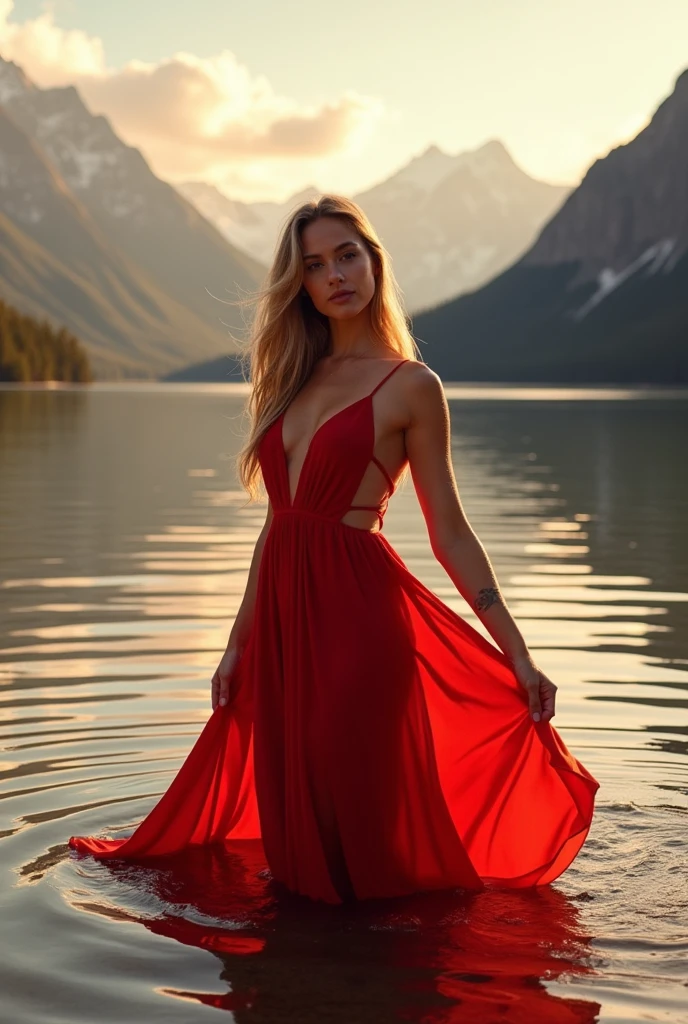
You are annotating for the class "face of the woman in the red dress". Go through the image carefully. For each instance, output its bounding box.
[301,217,377,319]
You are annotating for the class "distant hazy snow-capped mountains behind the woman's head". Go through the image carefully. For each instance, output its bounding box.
[177,141,569,310]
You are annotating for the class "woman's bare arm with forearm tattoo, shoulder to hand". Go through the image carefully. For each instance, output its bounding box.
[404,365,557,722]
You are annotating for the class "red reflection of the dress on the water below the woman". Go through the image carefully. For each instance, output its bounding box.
[66,844,599,1024]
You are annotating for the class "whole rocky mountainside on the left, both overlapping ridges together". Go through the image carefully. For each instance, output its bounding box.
[0,58,264,377]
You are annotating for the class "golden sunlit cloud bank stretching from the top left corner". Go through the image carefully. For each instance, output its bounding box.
[0,0,385,193]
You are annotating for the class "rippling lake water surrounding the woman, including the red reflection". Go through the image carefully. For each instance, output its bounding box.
[0,385,688,1024]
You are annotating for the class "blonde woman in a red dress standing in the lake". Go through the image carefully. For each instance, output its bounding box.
[70,196,598,903]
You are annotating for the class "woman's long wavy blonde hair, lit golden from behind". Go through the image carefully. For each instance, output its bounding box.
[237,195,421,500]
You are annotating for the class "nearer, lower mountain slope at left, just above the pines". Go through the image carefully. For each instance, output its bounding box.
[0,106,224,377]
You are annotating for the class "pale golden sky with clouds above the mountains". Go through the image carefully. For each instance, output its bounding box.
[0,0,688,202]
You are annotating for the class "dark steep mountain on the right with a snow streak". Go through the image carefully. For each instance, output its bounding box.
[414,72,688,383]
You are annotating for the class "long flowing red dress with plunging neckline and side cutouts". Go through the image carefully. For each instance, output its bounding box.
[70,360,599,903]
